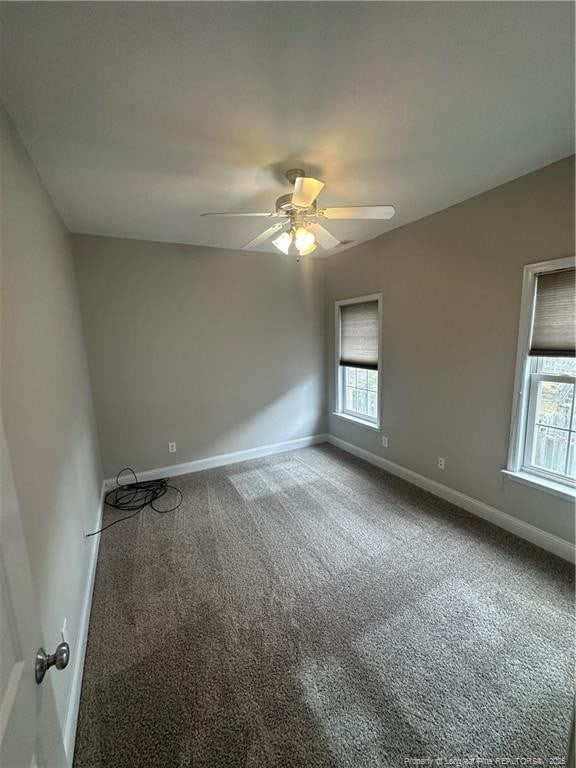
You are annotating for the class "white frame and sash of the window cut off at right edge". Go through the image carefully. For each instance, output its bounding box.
[504,256,576,498]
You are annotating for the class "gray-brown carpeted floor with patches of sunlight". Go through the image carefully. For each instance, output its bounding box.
[75,445,574,768]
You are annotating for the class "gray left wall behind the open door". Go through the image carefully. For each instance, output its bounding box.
[0,100,101,723]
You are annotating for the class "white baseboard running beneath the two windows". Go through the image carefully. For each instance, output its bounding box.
[328,435,575,563]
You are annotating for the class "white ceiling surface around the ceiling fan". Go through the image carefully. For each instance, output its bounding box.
[1,2,574,250]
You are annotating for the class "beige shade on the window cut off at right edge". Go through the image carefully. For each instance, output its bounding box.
[530,269,576,357]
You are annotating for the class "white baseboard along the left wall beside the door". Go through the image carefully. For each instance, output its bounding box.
[63,483,105,765]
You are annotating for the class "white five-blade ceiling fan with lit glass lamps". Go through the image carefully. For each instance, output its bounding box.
[202,168,396,261]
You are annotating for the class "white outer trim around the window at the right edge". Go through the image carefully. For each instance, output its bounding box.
[502,256,576,498]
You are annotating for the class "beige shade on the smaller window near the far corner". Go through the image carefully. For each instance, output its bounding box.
[340,301,378,370]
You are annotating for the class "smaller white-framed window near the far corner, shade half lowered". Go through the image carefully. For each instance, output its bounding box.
[336,295,381,428]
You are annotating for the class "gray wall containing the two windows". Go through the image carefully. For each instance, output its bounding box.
[326,158,574,540]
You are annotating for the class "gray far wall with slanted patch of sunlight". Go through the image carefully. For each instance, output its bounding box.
[73,235,325,477]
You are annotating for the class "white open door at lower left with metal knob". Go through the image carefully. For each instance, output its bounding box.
[0,413,69,768]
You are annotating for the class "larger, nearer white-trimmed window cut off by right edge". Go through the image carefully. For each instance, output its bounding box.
[507,258,576,494]
